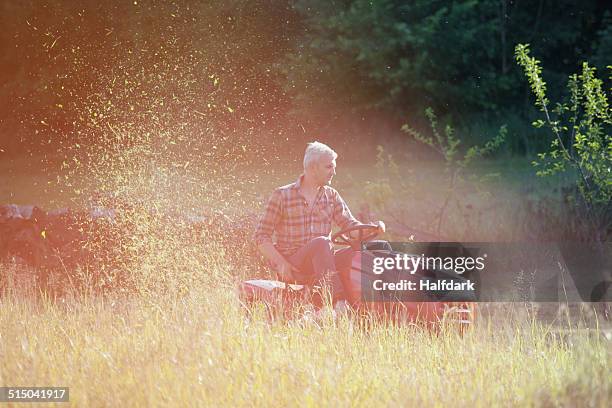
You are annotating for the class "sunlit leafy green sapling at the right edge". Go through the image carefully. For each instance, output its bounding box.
[516,44,612,240]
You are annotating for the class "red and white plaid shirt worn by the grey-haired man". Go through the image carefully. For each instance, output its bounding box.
[255,175,359,256]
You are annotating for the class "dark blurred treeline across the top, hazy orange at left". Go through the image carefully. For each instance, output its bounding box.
[0,0,612,155]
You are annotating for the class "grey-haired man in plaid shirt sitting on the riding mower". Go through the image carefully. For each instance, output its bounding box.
[255,142,385,310]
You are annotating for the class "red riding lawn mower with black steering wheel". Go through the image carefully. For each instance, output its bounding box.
[238,224,477,331]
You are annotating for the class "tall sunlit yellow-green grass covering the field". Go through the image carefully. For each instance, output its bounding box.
[0,151,612,407]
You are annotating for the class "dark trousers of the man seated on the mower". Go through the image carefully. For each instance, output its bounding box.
[287,237,355,302]
